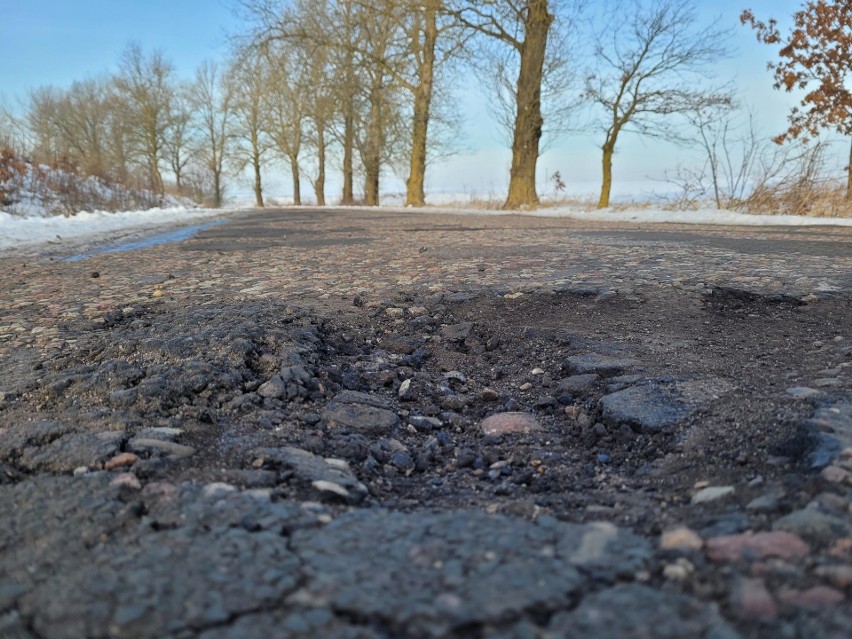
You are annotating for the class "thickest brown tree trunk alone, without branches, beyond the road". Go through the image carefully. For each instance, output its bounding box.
[503,0,553,209]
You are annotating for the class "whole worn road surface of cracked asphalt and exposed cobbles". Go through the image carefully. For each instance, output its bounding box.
[0,209,852,639]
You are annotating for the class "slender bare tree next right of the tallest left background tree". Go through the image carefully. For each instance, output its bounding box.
[193,61,233,208]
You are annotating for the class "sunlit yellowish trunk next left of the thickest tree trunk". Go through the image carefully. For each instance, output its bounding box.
[405,3,438,206]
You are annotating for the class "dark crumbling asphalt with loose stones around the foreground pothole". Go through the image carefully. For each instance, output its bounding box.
[0,290,852,639]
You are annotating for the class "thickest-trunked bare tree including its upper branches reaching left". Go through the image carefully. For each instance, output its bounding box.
[452,0,554,209]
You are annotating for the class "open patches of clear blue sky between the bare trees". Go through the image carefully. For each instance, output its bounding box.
[0,0,840,200]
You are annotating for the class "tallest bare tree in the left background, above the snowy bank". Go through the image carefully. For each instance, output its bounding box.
[115,42,174,194]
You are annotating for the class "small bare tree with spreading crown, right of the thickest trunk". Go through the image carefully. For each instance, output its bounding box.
[586,0,730,208]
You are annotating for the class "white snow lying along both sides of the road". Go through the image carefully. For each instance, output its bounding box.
[0,198,852,250]
